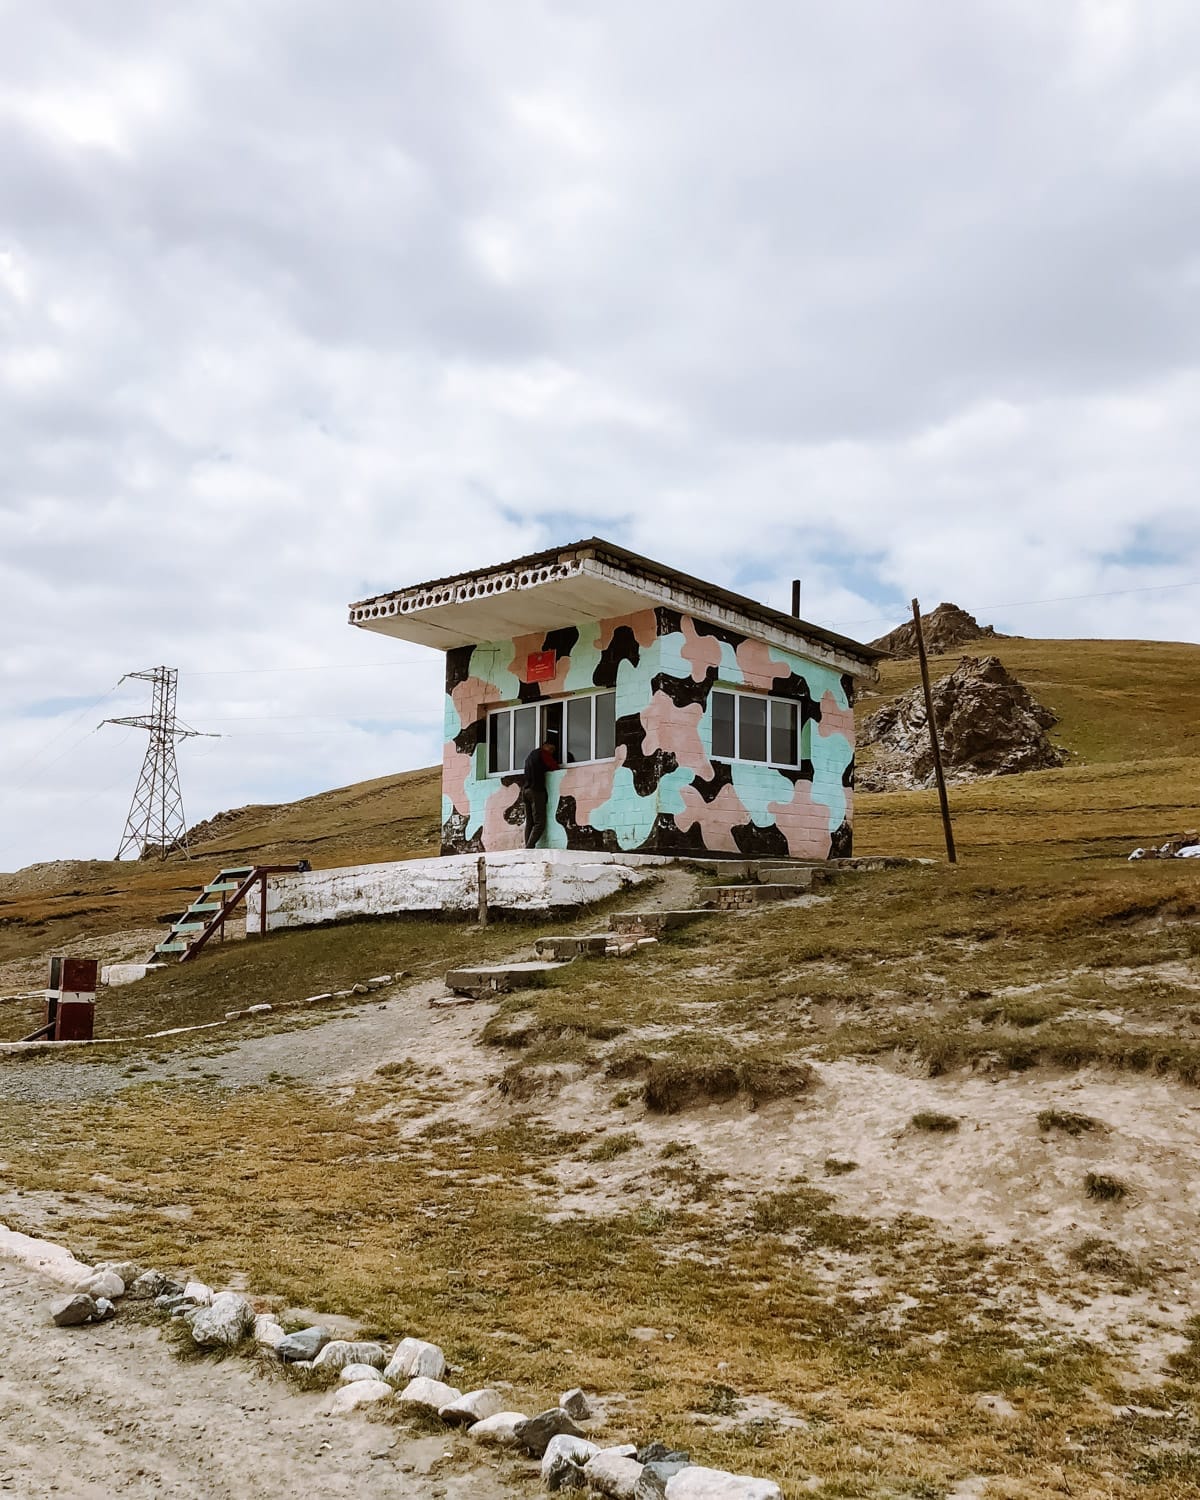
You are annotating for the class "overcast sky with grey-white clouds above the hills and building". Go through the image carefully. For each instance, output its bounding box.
[0,0,1200,869]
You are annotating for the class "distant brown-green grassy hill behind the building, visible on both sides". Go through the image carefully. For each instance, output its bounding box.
[0,639,1200,965]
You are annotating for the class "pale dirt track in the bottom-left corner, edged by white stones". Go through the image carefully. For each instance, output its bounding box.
[0,1259,515,1500]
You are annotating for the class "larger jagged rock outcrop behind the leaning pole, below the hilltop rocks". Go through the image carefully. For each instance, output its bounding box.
[855,657,1067,792]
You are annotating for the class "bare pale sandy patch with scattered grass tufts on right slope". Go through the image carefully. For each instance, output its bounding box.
[510,1061,1200,1382]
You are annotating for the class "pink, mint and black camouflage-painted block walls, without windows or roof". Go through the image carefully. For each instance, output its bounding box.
[443,609,854,860]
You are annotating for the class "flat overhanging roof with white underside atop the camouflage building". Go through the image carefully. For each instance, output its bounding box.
[350,537,887,677]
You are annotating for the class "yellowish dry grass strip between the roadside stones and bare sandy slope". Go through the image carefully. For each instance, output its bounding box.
[0,1080,1182,1500]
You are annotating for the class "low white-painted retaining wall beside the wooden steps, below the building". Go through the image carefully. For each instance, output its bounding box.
[246,849,672,933]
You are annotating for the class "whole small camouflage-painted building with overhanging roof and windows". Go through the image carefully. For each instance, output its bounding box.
[350,539,879,858]
